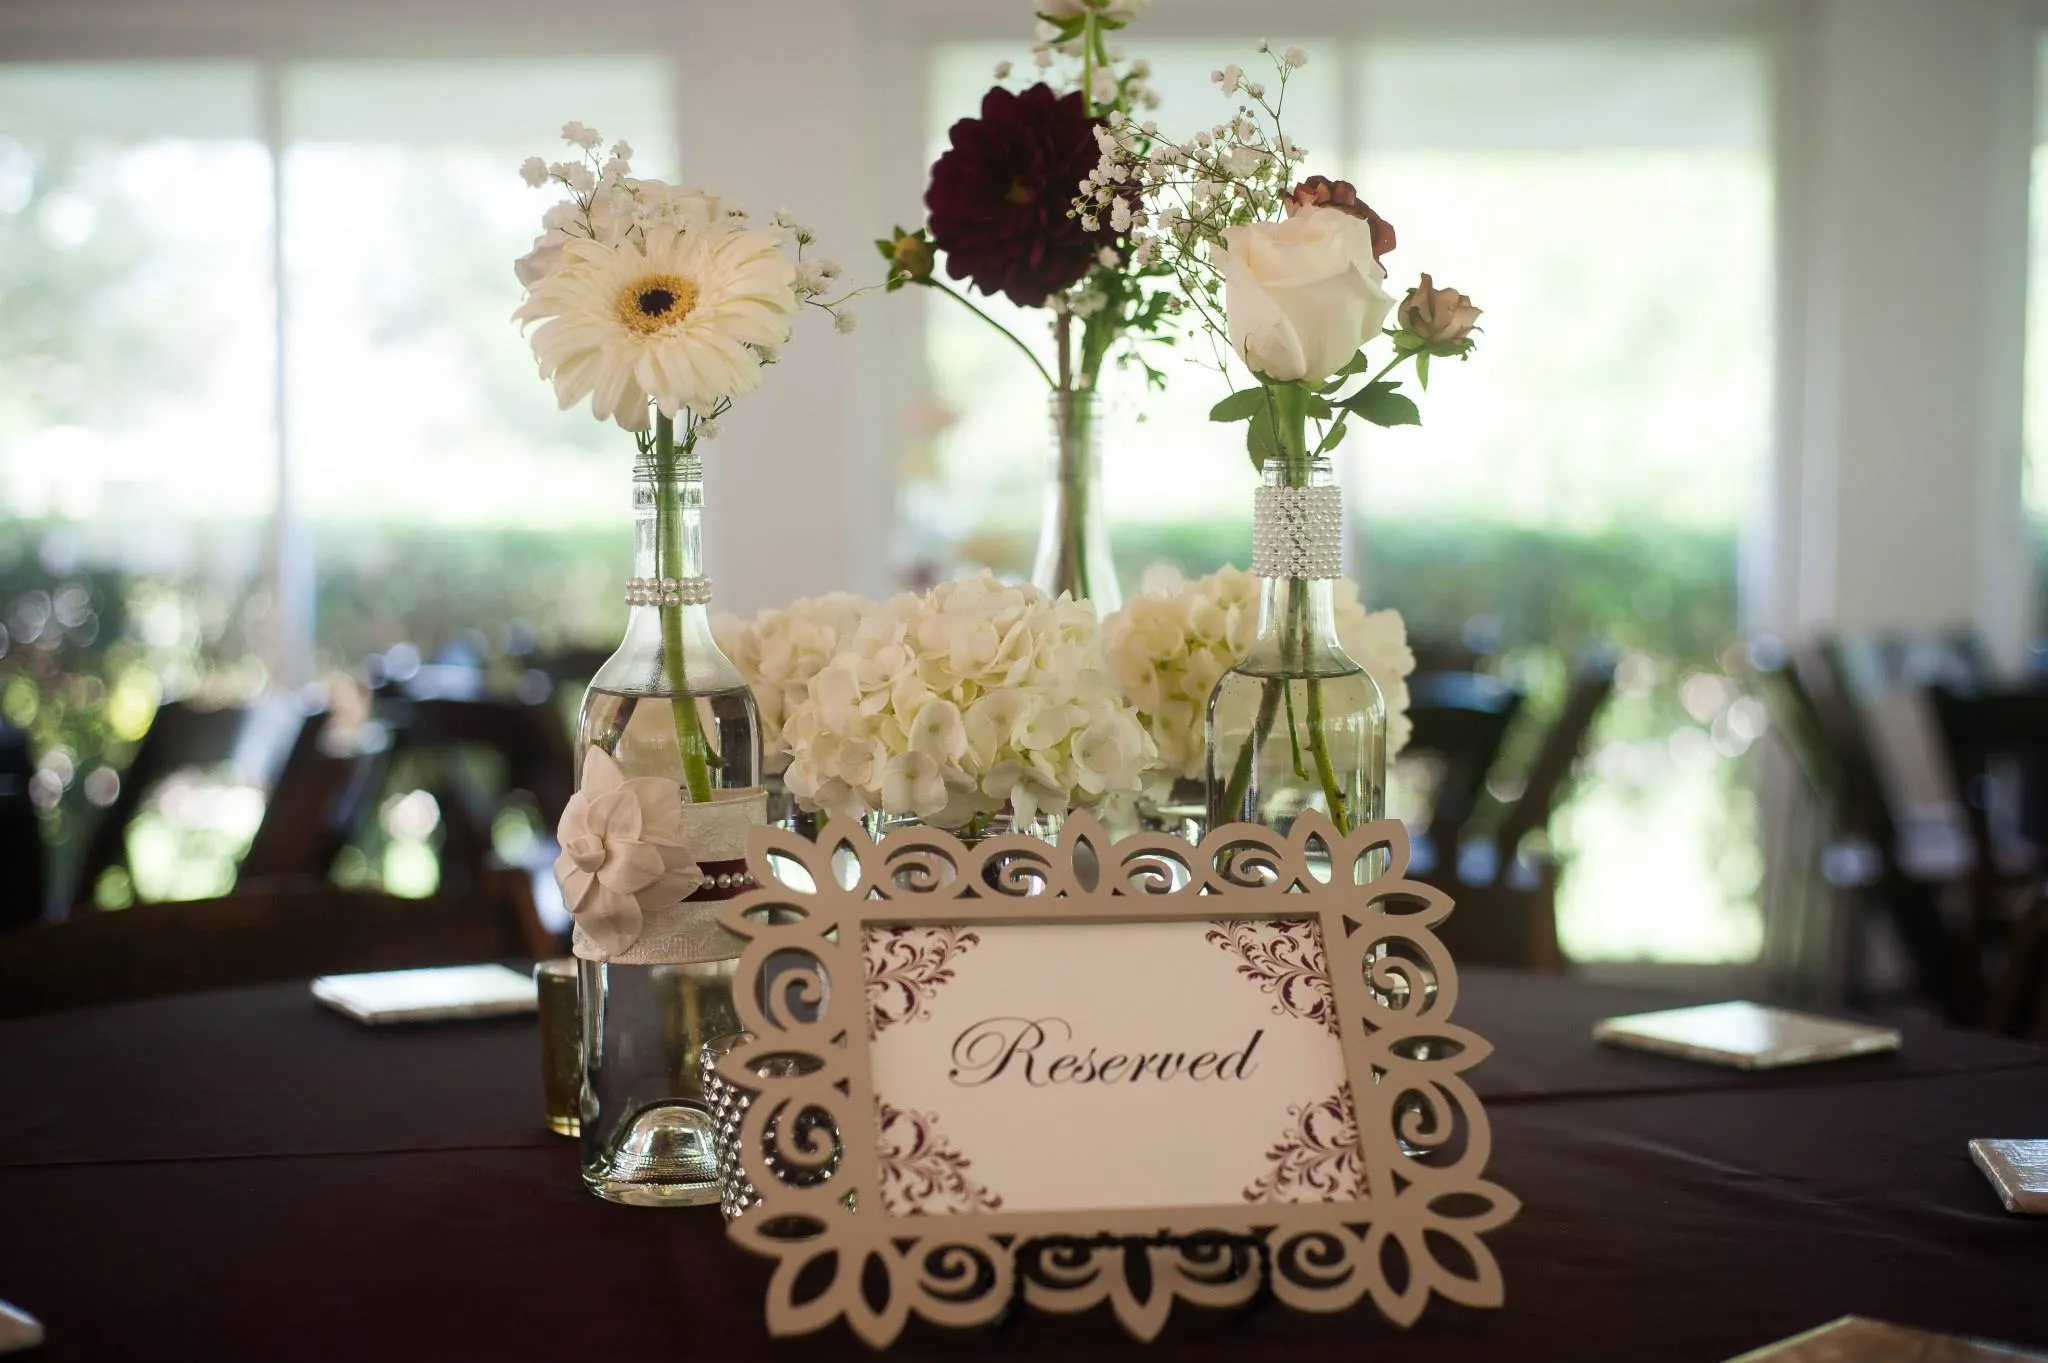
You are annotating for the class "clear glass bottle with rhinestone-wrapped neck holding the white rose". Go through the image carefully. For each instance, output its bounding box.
[1208,456,1386,833]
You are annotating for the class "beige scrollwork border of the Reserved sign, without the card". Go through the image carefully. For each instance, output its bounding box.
[719,812,1520,1347]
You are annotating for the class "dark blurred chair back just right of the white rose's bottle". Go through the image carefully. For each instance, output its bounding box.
[1399,671,1522,872]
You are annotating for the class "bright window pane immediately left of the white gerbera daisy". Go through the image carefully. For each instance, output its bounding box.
[283,59,674,665]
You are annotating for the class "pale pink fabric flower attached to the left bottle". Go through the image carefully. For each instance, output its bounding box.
[555,747,705,956]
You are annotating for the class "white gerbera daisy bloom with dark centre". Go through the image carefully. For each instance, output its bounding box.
[512,223,799,430]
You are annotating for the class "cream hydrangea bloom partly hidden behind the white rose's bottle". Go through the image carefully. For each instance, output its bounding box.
[1102,567,1415,780]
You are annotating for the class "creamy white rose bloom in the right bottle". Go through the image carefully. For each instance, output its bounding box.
[1217,207,1395,383]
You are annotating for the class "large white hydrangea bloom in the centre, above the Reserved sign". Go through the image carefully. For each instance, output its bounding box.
[774,573,1155,827]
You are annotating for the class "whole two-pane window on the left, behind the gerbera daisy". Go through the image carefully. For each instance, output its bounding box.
[0,57,674,900]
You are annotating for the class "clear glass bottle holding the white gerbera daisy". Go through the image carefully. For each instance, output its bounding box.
[575,454,766,1205]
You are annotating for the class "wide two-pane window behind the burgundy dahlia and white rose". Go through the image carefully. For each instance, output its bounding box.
[905,37,1774,960]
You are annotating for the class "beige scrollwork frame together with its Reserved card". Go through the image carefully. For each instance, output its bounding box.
[719,815,1520,1347]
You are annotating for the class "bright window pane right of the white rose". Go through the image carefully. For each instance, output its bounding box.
[1350,41,1774,960]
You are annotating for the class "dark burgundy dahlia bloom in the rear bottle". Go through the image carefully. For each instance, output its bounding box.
[924,84,1116,307]
